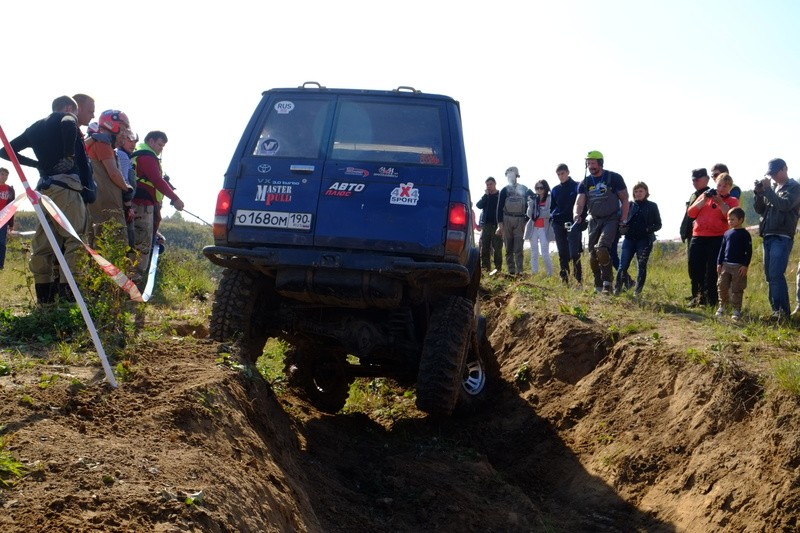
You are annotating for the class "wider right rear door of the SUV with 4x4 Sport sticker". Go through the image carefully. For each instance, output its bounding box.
[314,93,451,258]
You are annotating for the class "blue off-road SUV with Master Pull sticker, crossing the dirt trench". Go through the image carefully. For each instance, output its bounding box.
[204,82,497,415]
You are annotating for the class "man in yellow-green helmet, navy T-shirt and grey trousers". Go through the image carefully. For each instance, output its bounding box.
[574,150,630,294]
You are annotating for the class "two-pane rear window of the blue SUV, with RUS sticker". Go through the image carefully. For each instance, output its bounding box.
[253,99,444,166]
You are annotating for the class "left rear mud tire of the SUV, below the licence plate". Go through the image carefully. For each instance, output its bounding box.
[209,268,274,363]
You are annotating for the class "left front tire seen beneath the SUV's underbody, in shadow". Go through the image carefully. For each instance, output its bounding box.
[284,349,354,414]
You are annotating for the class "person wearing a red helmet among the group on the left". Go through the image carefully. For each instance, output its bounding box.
[86,109,133,246]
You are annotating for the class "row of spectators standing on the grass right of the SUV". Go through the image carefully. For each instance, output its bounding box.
[476,150,800,321]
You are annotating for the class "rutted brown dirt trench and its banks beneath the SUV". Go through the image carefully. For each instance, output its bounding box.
[0,288,800,532]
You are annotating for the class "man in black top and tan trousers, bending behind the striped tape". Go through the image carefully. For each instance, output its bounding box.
[0,96,94,304]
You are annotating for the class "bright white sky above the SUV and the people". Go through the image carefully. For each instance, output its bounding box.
[0,0,800,239]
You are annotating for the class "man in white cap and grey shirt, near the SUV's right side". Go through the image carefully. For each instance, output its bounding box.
[497,167,533,276]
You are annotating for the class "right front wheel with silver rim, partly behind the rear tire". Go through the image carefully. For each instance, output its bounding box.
[454,316,500,416]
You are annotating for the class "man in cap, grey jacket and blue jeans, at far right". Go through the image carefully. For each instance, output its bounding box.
[753,159,800,320]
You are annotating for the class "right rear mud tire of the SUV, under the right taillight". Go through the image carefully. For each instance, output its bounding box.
[417,296,475,416]
